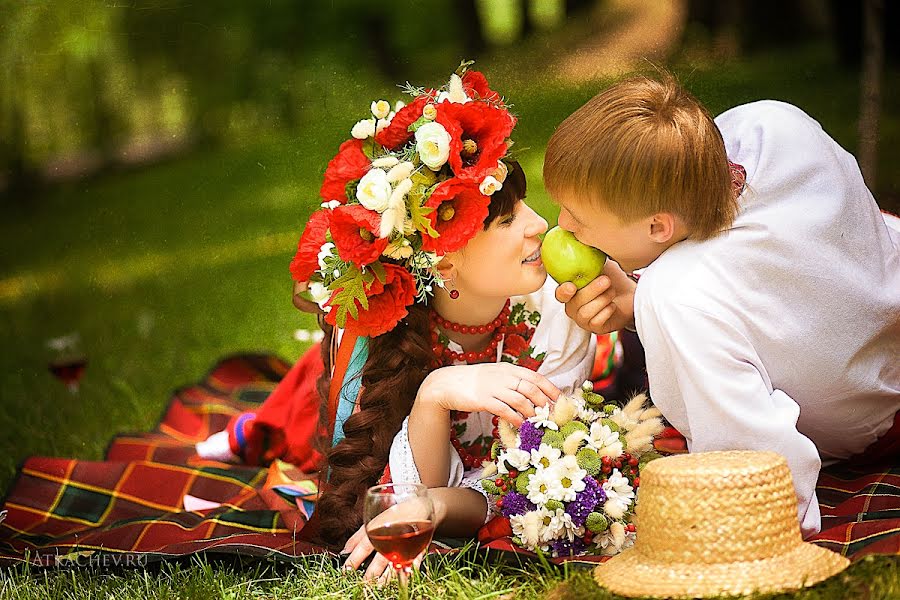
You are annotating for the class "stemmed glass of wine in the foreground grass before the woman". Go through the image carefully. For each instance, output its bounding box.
[364,483,434,600]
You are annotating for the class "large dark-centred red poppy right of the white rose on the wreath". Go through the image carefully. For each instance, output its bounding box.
[435,102,516,184]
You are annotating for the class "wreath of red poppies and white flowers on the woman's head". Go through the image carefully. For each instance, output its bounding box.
[291,62,516,337]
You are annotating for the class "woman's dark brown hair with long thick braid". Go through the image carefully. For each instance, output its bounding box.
[316,161,525,546]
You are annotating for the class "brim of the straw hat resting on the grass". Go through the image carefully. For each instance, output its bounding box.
[594,542,850,598]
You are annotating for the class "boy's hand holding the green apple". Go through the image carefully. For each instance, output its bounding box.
[556,260,637,334]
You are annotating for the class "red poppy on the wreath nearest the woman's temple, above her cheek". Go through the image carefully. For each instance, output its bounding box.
[422,178,491,255]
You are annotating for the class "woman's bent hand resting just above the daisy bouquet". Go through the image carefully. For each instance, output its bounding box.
[419,363,560,427]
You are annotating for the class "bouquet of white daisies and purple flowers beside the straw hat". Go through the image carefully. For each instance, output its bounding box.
[481,382,663,556]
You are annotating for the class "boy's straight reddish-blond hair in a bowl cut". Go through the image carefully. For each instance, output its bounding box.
[544,73,737,239]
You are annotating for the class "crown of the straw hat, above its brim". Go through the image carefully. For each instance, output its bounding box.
[635,451,802,564]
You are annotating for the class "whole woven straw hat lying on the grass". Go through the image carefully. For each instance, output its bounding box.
[594,452,850,598]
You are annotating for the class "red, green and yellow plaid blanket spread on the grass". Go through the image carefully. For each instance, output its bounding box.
[0,355,900,566]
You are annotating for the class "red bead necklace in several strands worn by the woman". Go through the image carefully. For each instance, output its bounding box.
[431,300,515,469]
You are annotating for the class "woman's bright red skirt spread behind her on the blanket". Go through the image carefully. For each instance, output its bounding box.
[228,344,325,473]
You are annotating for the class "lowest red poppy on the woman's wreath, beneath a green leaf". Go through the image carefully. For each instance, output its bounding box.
[325,263,416,337]
